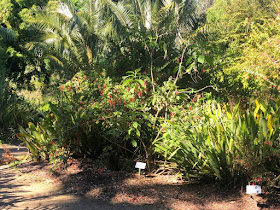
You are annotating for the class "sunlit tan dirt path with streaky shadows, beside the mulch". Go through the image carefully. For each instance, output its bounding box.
[0,166,156,210]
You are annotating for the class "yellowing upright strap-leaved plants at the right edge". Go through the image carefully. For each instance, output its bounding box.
[231,100,280,177]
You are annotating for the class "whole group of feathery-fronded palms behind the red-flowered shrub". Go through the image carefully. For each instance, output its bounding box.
[28,0,208,79]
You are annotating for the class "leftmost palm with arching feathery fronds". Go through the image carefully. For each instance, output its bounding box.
[28,1,103,76]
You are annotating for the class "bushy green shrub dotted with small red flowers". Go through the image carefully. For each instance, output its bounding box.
[18,69,190,171]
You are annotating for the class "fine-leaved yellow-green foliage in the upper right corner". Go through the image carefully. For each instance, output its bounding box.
[204,0,280,101]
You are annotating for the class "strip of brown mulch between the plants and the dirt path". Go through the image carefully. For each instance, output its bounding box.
[12,159,280,209]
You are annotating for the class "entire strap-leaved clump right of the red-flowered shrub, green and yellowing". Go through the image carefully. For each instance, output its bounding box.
[155,100,280,182]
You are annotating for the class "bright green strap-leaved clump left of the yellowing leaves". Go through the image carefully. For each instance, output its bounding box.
[156,99,238,180]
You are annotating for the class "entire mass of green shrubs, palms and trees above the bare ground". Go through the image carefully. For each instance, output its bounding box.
[0,0,280,188]
